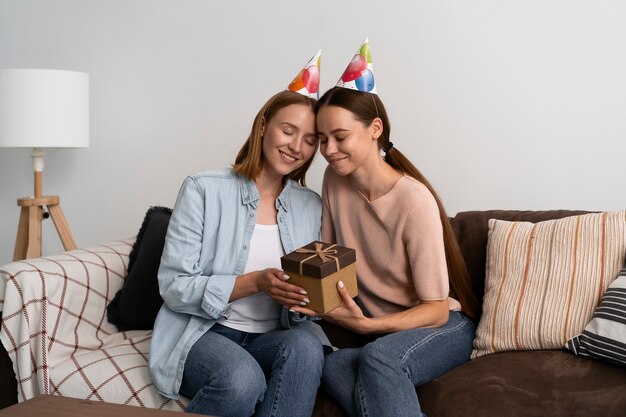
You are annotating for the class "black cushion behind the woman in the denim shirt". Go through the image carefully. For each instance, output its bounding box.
[107,207,172,330]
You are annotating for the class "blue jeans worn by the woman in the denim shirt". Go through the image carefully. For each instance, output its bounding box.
[180,324,324,417]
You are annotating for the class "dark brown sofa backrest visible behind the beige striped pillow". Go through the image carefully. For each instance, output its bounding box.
[451,210,589,312]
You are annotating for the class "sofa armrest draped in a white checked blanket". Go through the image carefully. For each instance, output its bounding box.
[0,239,133,401]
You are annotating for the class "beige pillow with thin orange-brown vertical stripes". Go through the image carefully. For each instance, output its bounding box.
[472,211,626,358]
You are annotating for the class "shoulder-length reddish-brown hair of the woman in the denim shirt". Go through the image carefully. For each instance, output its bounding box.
[233,90,317,185]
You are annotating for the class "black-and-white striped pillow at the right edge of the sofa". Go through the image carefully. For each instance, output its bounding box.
[565,264,626,366]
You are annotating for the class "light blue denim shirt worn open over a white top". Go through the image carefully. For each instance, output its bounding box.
[150,169,330,398]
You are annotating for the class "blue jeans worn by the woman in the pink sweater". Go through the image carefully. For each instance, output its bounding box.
[322,311,474,417]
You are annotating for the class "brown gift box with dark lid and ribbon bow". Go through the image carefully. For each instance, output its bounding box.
[280,241,358,313]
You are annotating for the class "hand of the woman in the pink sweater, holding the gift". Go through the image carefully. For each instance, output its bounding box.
[291,281,373,334]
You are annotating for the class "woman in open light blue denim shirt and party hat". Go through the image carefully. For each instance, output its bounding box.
[150,53,328,417]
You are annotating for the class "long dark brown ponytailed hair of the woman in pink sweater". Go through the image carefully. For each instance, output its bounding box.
[315,87,478,319]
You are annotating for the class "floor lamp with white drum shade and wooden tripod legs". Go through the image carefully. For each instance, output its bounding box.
[0,69,89,261]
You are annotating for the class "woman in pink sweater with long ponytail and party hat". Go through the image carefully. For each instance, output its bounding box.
[293,41,476,417]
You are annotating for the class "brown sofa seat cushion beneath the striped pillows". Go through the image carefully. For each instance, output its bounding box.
[417,350,626,417]
